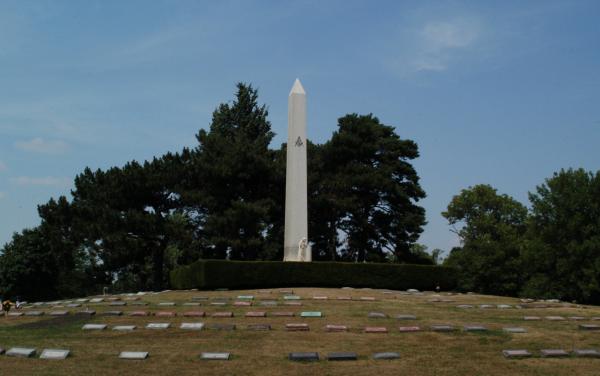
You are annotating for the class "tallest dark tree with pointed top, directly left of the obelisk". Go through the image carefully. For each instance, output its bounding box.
[184,83,283,260]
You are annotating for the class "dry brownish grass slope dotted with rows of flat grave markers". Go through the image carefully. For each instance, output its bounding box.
[0,288,600,376]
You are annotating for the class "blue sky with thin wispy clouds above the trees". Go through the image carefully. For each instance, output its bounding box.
[0,0,600,256]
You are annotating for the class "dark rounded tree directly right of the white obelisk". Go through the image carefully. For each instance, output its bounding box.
[316,114,425,262]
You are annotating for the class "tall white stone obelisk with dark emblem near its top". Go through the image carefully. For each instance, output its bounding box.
[283,79,312,261]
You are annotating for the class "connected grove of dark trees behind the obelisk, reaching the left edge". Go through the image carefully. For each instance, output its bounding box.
[0,83,430,298]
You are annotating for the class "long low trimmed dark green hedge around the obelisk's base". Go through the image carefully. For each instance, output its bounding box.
[170,260,456,290]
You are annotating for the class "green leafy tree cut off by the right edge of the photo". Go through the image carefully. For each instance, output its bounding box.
[523,169,600,304]
